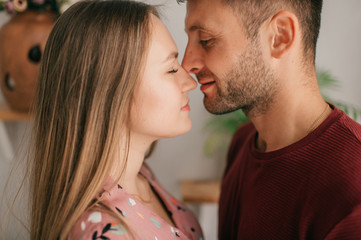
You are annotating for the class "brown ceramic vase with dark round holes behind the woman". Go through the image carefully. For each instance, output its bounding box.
[0,10,56,112]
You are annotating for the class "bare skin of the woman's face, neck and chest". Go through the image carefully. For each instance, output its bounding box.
[111,16,197,225]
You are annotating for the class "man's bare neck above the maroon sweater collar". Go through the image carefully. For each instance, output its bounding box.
[250,90,331,152]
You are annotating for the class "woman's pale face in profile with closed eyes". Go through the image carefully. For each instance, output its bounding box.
[131,15,197,140]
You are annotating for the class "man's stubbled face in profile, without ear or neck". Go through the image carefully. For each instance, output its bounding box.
[183,0,276,114]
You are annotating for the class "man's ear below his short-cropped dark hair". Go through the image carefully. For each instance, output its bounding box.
[270,11,298,58]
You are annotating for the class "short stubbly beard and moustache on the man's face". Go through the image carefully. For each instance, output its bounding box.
[197,42,277,116]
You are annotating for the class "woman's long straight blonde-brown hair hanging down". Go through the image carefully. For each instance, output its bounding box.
[28,0,158,240]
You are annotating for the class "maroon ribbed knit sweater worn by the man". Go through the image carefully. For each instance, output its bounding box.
[219,106,361,240]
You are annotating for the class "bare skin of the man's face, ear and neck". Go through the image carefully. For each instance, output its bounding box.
[183,0,331,151]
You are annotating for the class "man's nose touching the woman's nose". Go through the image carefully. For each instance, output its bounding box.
[182,43,203,74]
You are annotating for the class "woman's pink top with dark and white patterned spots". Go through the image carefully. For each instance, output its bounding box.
[68,165,203,240]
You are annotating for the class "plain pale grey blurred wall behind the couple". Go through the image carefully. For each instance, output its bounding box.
[0,0,361,240]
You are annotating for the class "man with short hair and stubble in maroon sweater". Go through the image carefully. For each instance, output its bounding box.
[179,0,361,240]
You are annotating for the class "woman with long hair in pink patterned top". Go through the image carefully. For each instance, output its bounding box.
[29,1,202,240]
